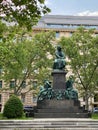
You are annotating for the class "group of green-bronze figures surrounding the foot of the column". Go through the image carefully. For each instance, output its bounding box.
[38,76,78,101]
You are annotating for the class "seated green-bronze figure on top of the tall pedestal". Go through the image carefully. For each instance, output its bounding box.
[53,45,66,70]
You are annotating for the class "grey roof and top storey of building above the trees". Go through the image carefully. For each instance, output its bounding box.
[33,15,98,38]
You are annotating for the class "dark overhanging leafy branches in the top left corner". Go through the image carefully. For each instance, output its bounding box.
[0,0,50,29]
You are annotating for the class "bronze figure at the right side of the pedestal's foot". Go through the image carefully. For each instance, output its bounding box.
[64,76,78,100]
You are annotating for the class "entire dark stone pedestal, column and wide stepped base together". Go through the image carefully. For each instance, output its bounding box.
[34,70,88,118]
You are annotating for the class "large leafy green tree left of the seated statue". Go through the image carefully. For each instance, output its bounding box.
[0,23,55,95]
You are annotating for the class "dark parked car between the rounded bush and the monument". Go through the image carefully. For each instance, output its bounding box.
[23,106,34,117]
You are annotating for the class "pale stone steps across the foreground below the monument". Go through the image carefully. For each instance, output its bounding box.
[0,118,98,130]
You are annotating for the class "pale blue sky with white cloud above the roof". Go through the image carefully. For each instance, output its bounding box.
[46,0,98,16]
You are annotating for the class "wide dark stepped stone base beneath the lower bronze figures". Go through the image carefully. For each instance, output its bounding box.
[34,99,89,118]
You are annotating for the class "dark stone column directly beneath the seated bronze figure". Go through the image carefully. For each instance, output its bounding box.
[52,70,66,90]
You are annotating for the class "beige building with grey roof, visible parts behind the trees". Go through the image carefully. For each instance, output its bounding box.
[0,15,98,111]
